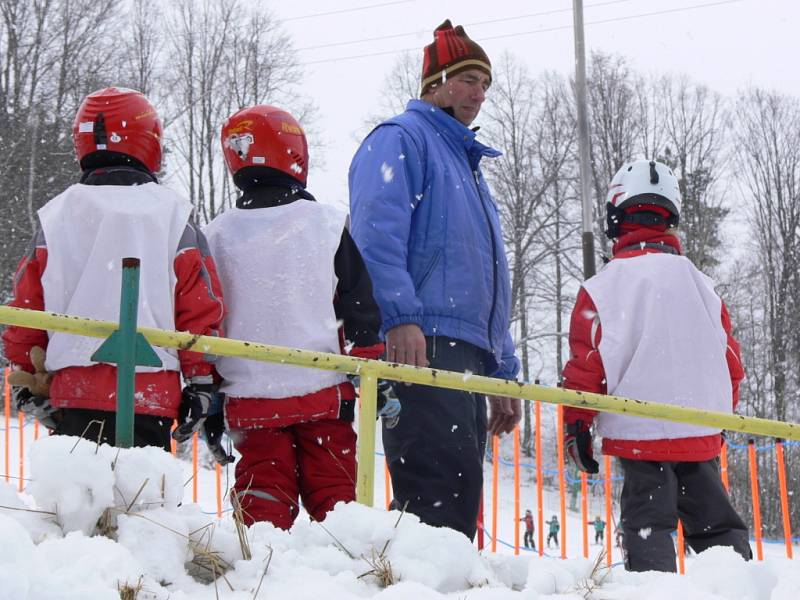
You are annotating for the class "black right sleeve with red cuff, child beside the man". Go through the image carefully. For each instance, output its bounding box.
[333,229,384,358]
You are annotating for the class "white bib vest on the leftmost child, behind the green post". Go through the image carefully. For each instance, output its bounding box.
[39,183,192,372]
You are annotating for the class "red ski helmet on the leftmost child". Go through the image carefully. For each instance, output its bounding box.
[72,87,161,173]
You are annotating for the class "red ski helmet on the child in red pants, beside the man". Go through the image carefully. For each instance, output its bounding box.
[221,104,308,186]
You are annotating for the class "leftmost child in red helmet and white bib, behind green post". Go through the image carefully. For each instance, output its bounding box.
[3,87,223,450]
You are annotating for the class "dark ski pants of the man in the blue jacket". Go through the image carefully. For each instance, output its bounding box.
[383,336,486,540]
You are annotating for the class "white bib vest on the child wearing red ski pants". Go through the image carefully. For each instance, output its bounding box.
[205,200,347,398]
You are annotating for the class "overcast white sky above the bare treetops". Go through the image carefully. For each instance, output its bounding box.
[270,0,800,205]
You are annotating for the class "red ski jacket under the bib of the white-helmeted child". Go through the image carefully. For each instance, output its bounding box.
[563,229,744,462]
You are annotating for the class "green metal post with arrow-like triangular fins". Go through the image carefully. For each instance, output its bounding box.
[92,258,162,448]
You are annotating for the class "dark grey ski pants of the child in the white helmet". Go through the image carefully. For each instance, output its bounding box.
[620,458,753,573]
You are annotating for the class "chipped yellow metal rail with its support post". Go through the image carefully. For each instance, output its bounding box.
[0,306,800,505]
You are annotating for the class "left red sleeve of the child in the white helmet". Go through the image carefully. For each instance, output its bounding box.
[562,288,607,424]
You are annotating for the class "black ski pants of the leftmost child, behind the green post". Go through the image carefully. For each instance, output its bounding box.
[53,408,173,452]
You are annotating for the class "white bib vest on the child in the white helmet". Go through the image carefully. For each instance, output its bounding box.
[583,253,732,440]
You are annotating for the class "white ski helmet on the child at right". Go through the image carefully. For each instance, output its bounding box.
[606,159,681,217]
